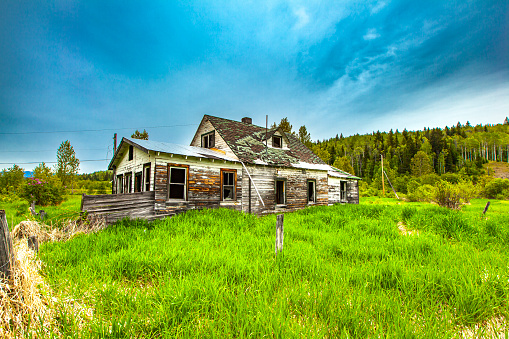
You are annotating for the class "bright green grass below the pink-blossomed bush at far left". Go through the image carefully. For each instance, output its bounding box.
[0,195,81,230]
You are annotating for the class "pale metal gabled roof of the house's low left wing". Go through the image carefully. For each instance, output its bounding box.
[108,138,238,170]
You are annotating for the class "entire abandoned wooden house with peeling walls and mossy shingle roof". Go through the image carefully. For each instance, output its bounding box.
[82,115,360,222]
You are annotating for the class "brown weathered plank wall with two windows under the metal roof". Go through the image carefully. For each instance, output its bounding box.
[155,155,242,213]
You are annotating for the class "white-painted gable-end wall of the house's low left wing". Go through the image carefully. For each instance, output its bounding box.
[114,144,155,193]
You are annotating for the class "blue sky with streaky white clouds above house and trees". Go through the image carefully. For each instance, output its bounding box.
[0,0,509,172]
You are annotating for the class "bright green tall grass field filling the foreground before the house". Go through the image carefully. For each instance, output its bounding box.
[39,200,509,338]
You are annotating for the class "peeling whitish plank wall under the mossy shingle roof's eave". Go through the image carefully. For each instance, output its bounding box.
[242,165,329,214]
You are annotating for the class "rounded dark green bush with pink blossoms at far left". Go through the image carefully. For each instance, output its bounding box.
[21,178,65,206]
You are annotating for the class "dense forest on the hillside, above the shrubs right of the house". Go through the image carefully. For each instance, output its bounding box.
[313,121,509,180]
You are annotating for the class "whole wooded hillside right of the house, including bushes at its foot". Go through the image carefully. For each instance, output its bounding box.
[273,118,509,201]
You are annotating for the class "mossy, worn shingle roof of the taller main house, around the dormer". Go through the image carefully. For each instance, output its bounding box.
[203,115,326,167]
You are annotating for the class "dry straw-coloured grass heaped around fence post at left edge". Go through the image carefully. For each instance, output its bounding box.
[0,216,106,338]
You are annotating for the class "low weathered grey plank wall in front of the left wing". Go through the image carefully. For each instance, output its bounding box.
[81,191,155,224]
